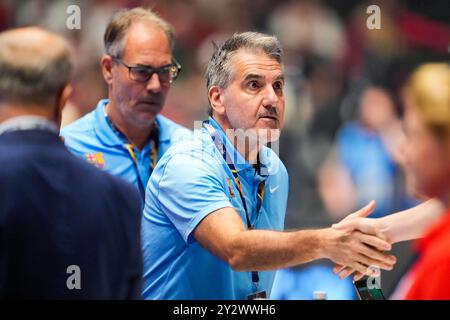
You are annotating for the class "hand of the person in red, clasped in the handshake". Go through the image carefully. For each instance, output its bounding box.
[332,201,391,281]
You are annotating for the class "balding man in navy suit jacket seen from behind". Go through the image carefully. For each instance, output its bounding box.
[0,27,142,299]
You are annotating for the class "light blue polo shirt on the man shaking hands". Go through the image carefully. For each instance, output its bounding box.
[141,118,288,299]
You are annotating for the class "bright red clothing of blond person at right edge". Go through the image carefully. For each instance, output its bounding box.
[405,211,450,300]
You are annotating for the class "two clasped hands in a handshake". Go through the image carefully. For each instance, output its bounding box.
[322,201,396,281]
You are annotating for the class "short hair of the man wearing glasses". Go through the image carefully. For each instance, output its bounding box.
[103,7,175,58]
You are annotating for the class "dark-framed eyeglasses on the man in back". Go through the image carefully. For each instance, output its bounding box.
[112,57,181,84]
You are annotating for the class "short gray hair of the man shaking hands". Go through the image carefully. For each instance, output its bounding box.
[205,32,283,116]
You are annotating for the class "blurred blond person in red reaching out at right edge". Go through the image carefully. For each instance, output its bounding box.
[334,63,450,292]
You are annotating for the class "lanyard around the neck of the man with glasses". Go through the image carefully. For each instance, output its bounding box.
[105,111,159,201]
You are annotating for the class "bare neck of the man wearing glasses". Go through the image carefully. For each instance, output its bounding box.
[105,103,154,150]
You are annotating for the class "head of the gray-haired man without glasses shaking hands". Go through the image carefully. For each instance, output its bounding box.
[206,32,285,140]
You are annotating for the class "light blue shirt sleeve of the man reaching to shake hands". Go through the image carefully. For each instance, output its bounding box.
[156,154,233,243]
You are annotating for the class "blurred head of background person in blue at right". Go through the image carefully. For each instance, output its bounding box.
[359,87,396,131]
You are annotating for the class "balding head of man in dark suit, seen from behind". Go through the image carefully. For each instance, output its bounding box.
[0,27,73,124]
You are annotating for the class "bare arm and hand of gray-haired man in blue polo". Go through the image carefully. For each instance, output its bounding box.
[194,208,393,273]
